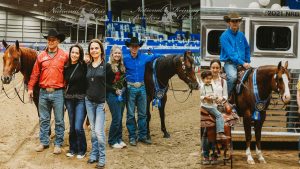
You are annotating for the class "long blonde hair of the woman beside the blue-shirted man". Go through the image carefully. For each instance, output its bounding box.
[108,45,125,73]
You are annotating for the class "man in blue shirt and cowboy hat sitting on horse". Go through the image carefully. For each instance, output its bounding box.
[220,13,250,96]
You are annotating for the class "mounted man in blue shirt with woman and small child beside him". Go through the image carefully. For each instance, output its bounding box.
[200,13,250,165]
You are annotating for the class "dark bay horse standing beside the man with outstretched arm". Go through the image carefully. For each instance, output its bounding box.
[145,52,199,139]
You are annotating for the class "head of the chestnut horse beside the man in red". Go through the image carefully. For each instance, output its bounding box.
[1,40,21,84]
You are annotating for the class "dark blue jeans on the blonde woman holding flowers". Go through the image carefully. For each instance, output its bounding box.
[106,92,125,145]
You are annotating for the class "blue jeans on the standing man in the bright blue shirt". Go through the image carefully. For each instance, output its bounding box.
[126,85,147,140]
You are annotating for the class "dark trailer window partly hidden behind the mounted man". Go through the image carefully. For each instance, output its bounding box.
[207,30,224,55]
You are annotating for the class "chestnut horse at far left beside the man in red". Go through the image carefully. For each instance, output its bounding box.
[1,40,40,115]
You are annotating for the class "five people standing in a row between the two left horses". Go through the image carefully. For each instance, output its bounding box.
[28,29,160,168]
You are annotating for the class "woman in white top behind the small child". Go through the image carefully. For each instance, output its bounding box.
[202,59,228,165]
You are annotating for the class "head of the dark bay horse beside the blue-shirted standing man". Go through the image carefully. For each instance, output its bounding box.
[176,53,199,90]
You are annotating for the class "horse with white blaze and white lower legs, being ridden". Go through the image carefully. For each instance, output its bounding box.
[231,62,291,164]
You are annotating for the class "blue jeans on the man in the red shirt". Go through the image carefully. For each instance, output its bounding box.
[39,89,65,147]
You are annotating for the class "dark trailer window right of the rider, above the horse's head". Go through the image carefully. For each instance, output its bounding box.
[256,26,291,51]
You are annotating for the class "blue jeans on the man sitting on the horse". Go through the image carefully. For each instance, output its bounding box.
[224,62,237,96]
